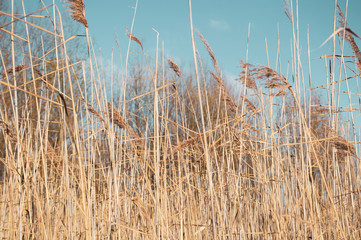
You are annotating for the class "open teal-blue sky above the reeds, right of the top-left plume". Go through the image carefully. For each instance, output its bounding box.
[85,0,361,87]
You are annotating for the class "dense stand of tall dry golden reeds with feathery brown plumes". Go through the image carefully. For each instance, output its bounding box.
[0,0,361,239]
